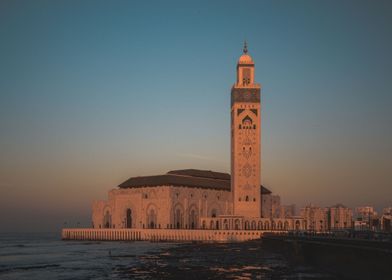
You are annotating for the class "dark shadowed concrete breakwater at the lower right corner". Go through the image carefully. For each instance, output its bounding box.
[262,235,392,279]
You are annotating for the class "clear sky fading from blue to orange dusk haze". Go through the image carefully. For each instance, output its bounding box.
[0,0,392,231]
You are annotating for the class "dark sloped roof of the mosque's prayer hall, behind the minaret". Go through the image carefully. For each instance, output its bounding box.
[119,169,271,194]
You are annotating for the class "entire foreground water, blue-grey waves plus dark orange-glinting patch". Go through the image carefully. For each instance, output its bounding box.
[0,233,338,280]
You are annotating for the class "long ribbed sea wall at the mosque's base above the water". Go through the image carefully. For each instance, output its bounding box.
[61,228,282,242]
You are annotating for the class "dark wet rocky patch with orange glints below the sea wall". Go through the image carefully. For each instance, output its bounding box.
[117,240,337,280]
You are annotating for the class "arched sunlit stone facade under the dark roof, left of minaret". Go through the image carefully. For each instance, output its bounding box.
[93,183,232,229]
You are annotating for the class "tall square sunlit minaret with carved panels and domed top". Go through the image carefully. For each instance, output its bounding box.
[231,42,261,218]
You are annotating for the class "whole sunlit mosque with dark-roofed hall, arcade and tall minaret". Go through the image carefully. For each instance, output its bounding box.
[63,43,303,240]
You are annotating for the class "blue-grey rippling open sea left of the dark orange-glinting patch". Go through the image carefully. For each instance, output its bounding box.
[0,233,176,280]
